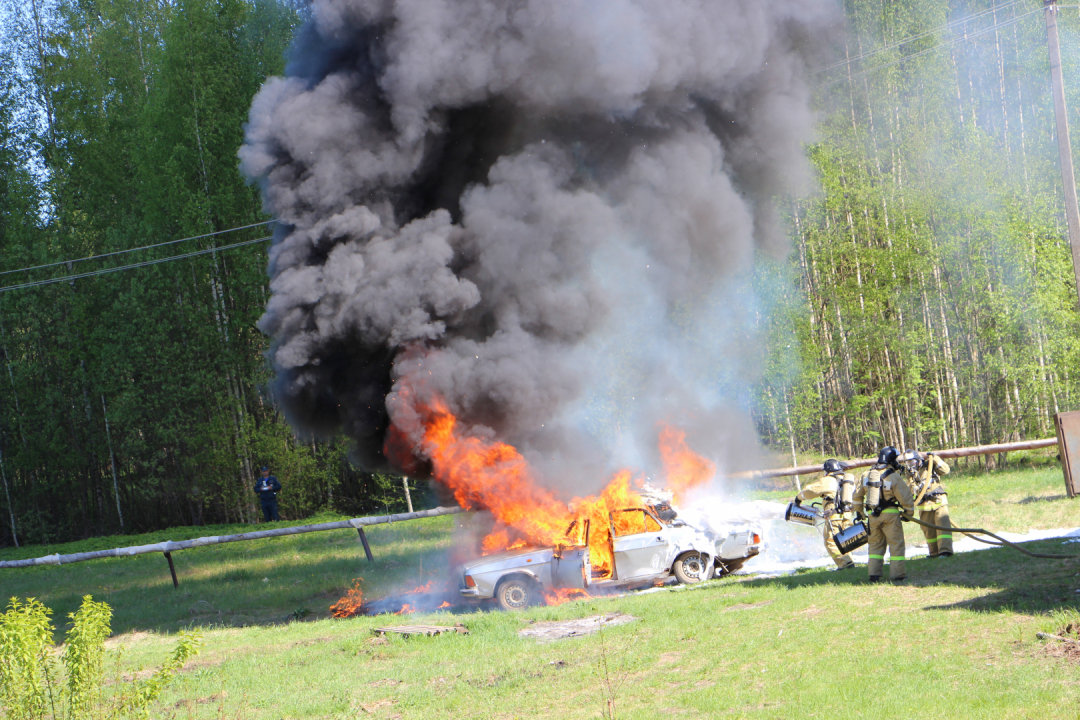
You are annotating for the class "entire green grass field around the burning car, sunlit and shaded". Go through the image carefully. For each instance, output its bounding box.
[0,467,1080,719]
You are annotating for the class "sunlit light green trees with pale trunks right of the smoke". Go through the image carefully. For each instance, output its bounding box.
[757,0,1080,466]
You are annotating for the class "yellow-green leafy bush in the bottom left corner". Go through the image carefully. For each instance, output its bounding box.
[0,595,200,720]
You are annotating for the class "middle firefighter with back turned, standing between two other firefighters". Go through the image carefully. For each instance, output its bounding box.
[854,447,915,582]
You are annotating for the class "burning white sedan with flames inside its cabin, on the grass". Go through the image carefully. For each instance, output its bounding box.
[460,505,762,610]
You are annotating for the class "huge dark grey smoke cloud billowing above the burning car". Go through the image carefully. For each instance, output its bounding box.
[240,0,839,493]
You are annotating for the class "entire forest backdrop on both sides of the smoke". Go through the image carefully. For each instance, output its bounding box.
[0,0,1080,546]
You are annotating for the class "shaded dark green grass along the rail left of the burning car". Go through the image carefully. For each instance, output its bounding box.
[0,516,455,633]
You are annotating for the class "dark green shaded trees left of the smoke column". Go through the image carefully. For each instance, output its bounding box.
[0,0,425,545]
